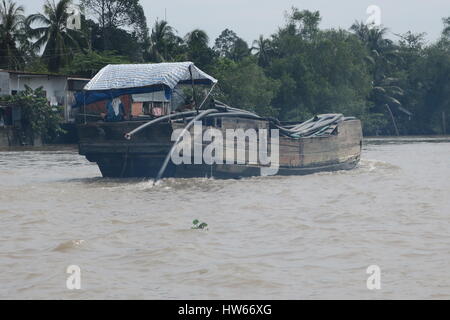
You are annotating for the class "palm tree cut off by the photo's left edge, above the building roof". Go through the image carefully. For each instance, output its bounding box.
[0,0,26,70]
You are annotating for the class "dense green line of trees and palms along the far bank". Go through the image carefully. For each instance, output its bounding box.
[0,0,450,135]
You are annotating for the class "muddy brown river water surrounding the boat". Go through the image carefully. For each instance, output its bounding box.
[0,137,450,299]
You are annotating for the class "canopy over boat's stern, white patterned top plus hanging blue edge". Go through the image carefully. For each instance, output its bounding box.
[74,62,217,107]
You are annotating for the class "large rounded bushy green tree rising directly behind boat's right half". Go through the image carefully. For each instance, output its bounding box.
[267,10,371,120]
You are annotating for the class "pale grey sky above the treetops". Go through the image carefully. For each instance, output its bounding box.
[16,0,450,45]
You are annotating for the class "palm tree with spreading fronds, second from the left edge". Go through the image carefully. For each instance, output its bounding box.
[27,0,85,72]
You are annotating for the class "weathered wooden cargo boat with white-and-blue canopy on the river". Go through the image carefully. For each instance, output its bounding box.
[77,62,362,179]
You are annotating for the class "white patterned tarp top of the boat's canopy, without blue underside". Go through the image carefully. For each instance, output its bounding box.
[84,62,217,91]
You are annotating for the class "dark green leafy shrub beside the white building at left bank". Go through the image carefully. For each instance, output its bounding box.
[0,86,64,140]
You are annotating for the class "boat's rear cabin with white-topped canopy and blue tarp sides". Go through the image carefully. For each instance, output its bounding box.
[74,62,217,123]
